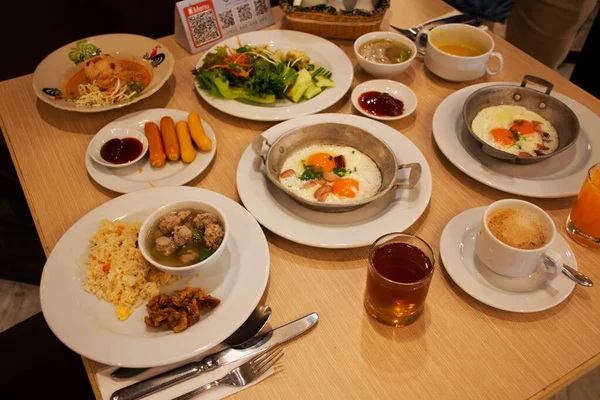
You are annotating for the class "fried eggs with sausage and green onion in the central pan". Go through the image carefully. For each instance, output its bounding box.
[279,145,382,204]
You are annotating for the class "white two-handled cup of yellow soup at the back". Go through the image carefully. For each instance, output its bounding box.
[415,24,504,82]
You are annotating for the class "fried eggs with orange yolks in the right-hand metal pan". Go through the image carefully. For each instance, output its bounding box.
[471,106,559,157]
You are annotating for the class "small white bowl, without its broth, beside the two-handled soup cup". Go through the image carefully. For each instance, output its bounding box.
[354,32,417,78]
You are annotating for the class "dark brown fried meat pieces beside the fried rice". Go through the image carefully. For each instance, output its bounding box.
[144,286,221,333]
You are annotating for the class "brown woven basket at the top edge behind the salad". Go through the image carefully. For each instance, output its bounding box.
[280,0,390,39]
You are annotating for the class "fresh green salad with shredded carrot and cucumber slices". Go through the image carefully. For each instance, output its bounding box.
[193,43,335,104]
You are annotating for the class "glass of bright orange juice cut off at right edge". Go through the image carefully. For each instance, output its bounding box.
[567,164,600,247]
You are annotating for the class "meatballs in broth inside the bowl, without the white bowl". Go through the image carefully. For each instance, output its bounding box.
[147,210,225,267]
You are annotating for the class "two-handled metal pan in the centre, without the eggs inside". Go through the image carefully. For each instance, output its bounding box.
[252,123,421,213]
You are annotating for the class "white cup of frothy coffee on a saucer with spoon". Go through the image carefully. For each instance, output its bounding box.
[475,199,563,279]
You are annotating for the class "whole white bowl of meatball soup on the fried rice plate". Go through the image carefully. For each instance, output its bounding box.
[138,201,228,276]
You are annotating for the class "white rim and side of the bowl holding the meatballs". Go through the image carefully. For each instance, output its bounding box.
[138,201,229,276]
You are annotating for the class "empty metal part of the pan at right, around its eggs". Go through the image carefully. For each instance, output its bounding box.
[463,75,579,164]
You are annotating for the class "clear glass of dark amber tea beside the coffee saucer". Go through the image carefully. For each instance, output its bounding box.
[365,233,435,326]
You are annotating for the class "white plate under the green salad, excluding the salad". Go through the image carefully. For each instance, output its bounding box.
[194,30,354,121]
